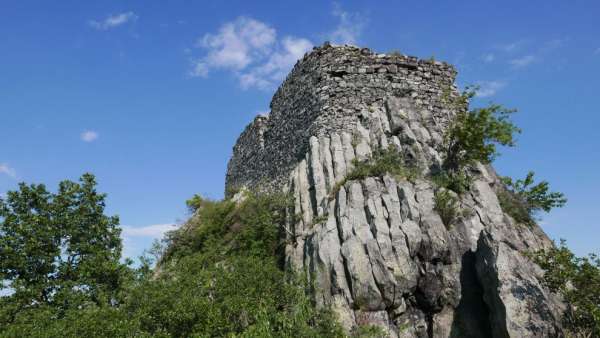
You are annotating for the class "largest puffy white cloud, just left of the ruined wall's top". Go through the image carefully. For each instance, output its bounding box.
[189,17,313,89]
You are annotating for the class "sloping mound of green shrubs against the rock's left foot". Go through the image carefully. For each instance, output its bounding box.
[118,194,342,337]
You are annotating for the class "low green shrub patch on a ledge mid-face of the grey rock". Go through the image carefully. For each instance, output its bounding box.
[331,147,420,198]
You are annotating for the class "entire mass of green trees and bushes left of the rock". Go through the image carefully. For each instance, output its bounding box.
[0,175,343,337]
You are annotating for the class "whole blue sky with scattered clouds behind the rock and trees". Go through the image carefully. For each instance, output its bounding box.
[0,0,600,256]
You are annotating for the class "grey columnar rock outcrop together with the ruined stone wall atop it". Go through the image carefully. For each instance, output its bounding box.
[227,45,562,337]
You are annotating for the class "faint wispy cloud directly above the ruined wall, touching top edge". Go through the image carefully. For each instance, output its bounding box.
[327,2,367,45]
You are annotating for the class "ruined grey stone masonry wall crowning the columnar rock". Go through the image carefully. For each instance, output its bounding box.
[226,43,456,195]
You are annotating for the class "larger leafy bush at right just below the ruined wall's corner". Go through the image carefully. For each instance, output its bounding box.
[444,88,520,171]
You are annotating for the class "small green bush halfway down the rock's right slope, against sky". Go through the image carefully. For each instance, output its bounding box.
[498,171,567,225]
